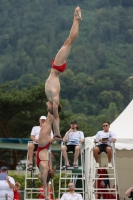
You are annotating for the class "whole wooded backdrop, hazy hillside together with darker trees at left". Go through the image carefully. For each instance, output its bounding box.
[0,0,133,169]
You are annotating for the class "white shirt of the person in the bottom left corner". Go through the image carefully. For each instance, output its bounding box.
[0,176,15,200]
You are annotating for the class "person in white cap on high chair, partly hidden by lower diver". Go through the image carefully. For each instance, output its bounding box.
[28,116,54,171]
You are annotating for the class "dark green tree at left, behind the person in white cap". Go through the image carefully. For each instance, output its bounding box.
[0,83,70,169]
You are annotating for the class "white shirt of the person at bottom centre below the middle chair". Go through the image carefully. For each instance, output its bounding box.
[60,192,83,200]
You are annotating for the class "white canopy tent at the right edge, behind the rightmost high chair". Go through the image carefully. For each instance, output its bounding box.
[85,100,133,197]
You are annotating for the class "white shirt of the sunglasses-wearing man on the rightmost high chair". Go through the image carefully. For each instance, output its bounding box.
[96,131,116,145]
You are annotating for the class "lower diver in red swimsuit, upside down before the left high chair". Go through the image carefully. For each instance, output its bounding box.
[36,102,59,200]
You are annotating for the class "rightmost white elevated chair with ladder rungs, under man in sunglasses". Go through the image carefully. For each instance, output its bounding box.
[87,143,118,200]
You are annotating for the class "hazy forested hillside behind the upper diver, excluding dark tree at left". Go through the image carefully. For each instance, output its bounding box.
[0,0,133,120]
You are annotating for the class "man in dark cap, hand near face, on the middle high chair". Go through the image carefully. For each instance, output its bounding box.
[61,120,84,169]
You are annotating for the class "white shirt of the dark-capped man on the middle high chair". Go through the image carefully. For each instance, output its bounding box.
[66,131,84,145]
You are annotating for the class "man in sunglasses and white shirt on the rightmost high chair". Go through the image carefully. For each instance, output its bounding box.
[93,121,116,168]
